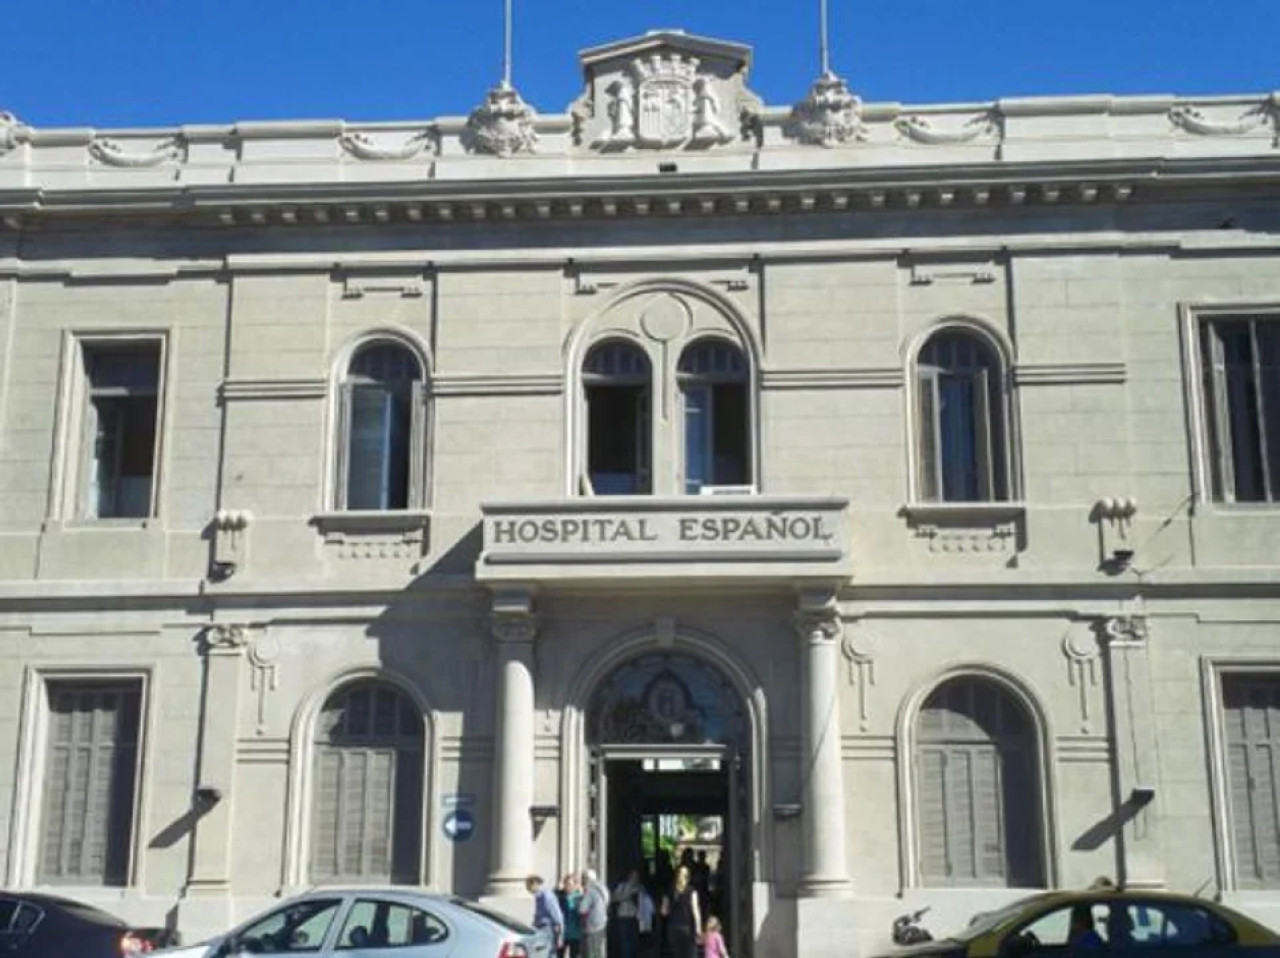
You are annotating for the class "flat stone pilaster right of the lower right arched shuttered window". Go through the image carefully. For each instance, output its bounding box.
[1098,615,1165,889]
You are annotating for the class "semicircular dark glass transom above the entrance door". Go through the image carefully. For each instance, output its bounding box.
[588,654,746,745]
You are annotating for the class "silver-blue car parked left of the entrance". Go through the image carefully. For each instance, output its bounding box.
[151,888,552,958]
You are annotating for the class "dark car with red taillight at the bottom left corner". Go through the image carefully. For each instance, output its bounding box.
[0,891,178,958]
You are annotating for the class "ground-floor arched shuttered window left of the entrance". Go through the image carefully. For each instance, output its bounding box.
[310,681,425,884]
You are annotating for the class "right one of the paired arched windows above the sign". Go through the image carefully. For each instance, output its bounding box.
[677,339,751,494]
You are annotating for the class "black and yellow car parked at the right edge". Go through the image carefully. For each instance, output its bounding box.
[892,886,1280,958]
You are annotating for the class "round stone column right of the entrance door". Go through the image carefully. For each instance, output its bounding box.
[795,594,850,898]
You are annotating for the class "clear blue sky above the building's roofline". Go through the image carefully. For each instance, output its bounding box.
[0,0,1280,127]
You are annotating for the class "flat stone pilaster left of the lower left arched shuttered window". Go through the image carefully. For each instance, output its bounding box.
[179,624,248,927]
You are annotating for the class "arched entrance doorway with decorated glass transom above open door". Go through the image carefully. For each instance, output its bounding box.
[585,652,753,955]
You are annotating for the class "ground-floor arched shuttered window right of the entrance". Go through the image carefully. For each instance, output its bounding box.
[915,676,1044,888]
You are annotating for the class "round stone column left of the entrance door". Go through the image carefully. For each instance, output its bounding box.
[485,590,538,898]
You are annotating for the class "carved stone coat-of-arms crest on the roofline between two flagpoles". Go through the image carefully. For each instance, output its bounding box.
[572,31,760,152]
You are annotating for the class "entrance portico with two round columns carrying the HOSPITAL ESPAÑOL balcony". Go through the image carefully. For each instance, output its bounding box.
[476,496,850,954]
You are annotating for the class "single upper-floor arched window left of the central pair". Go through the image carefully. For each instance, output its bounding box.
[338,342,426,510]
